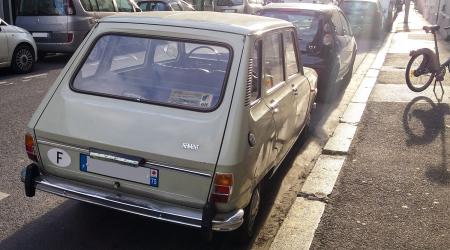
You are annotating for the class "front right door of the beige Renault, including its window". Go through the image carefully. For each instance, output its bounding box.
[283,30,311,134]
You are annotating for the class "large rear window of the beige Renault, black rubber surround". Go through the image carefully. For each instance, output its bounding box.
[72,35,231,111]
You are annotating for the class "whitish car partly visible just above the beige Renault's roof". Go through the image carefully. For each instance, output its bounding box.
[214,0,264,14]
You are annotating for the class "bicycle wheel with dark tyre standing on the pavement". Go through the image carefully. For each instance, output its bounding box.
[405,54,435,92]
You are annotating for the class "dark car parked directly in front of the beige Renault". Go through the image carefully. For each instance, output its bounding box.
[261,3,357,100]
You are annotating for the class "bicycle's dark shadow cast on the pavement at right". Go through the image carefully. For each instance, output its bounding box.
[403,96,450,185]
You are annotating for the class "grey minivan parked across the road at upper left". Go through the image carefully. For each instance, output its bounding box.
[16,0,140,56]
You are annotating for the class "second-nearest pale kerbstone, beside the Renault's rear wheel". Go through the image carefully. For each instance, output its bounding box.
[301,155,345,198]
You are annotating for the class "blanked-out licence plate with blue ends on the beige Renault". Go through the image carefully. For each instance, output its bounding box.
[80,154,159,187]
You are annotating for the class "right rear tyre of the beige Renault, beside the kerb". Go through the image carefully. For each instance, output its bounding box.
[235,185,261,244]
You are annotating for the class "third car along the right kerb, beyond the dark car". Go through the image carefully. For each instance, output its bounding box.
[341,0,389,38]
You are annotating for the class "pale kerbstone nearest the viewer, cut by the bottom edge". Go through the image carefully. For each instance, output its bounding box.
[270,197,325,250]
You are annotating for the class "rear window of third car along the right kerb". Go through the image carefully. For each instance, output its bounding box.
[341,1,377,25]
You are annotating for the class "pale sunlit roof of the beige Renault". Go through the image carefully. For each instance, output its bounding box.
[100,11,293,35]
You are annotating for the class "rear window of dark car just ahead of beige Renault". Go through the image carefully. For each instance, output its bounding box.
[262,9,320,42]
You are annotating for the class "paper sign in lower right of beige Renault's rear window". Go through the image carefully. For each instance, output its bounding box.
[169,89,213,108]
